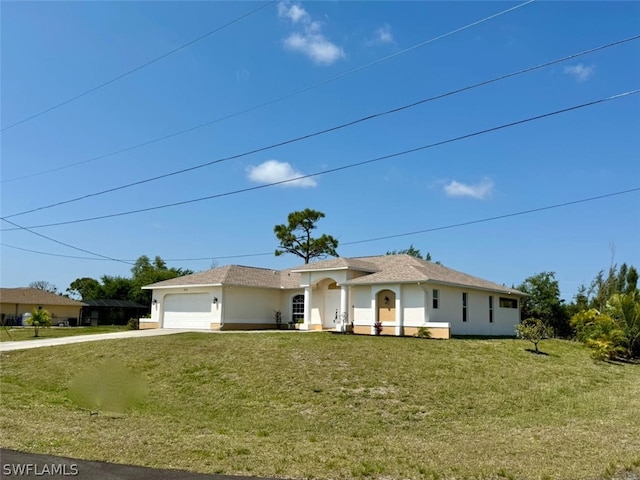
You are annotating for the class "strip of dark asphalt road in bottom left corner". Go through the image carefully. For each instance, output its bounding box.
[0,448,273,480]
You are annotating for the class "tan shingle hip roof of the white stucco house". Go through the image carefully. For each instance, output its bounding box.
[144,254,524,295]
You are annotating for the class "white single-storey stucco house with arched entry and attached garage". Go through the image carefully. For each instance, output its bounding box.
[140,255,524,338]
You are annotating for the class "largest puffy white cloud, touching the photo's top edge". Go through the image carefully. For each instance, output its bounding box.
[278,2,345,65]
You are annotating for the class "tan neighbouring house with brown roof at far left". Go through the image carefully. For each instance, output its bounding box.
[0,287,84,325]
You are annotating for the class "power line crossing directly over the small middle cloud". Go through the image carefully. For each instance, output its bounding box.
[0,89,640,231]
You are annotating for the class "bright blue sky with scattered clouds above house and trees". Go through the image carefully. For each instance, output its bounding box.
[0,1,640,299]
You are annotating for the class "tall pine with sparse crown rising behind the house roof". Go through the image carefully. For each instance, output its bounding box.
[273,208,338,263]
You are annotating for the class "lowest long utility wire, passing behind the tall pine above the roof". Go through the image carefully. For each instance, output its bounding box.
[0,187,640,262]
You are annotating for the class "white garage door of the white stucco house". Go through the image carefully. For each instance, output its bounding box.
[164,293,213,330]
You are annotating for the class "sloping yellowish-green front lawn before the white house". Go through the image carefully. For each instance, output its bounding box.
[0,333,640,479]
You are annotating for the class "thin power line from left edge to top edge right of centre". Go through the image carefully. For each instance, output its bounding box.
[1,0,535,183]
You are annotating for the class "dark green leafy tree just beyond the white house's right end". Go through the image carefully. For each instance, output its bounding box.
[517,272,571,336]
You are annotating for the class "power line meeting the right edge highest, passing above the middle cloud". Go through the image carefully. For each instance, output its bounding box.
[4,35,640,218]
